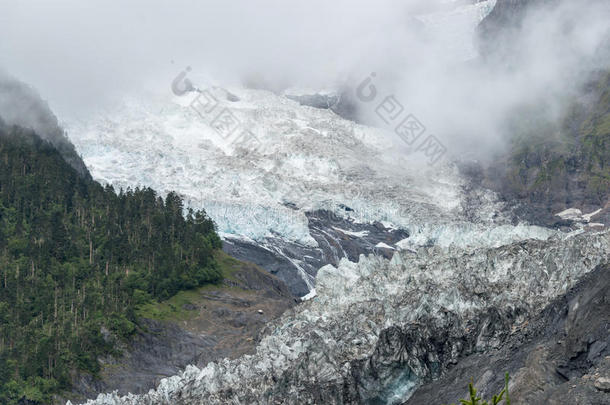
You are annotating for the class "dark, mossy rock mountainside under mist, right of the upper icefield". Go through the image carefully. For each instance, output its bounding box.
[464,71,610,226]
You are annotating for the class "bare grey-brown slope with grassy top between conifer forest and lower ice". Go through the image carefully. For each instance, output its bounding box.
[64,251,296,404]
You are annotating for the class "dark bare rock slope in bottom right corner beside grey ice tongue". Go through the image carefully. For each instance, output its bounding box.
[405,265,610,405]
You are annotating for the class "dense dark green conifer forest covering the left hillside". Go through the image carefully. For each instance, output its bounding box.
[0,123,222,404]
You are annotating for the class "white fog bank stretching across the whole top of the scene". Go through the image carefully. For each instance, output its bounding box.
[0,0,610,158]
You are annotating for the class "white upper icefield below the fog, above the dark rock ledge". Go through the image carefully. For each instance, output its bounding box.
[66,89,550,254]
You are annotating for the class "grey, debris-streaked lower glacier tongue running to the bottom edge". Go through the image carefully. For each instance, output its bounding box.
[73,232,610,404]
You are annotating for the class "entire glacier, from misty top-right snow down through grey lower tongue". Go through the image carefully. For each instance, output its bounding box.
[59,1,610,405]
